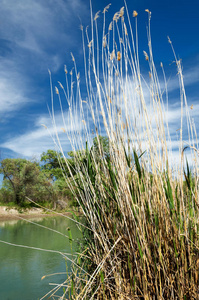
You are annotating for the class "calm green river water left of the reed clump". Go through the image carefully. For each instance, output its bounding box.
[0,217,81,300]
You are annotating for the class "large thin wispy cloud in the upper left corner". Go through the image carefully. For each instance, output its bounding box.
[0,0,88,113]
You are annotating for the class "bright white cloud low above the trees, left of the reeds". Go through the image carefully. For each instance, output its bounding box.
[1,113,82,157]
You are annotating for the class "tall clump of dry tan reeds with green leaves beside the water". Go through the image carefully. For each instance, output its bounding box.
[49,1,199,299]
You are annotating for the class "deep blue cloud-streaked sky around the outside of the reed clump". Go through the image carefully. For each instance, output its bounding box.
[0,0,199,159]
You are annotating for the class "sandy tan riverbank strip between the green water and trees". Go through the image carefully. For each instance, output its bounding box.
[0,206,69,221]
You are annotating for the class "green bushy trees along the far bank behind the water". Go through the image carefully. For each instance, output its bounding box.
[0,137,108,206]
